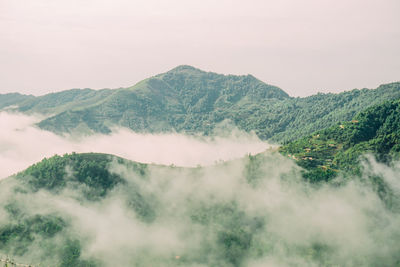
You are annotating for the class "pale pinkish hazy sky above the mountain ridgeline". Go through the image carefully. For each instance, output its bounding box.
[0,0,400,96]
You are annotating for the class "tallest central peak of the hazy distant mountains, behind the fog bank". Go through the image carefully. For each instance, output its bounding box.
[35,66,288,136]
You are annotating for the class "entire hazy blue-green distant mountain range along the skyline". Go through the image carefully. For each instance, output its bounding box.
[0,66,400,143]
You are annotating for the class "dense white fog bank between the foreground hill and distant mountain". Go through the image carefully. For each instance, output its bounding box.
[0,112,271,178]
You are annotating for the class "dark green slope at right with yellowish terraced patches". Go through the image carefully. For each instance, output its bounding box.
[280,100,400,180]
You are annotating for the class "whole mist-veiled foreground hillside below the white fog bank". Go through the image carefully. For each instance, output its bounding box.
[0,152,400,267]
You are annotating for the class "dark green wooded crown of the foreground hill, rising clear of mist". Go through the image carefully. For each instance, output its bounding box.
[16,153,146,200]
